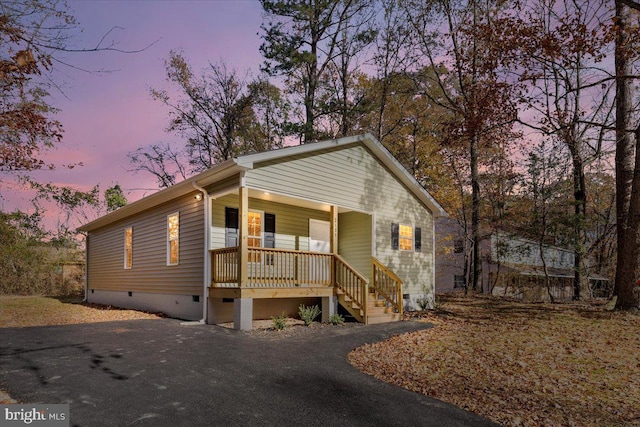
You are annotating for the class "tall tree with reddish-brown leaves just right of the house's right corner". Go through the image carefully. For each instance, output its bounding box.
[405,0,516,290]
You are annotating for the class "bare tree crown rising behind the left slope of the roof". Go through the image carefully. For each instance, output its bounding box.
[148,51,288,179]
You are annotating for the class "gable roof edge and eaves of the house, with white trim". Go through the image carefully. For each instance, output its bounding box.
[78,133,447,232]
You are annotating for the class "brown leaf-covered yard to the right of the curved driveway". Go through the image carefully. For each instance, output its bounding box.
[349,296,640,426]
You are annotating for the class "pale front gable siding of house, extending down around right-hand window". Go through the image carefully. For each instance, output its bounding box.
[246,143,435,307]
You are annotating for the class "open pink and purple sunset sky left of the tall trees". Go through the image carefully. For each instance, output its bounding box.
[0,0,262,224]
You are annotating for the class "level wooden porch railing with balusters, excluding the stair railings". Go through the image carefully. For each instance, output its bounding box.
[211,247,334,288]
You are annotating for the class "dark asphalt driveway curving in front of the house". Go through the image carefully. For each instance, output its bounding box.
[0,319,492,426]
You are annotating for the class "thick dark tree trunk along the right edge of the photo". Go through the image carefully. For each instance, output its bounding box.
[614,0,640,309]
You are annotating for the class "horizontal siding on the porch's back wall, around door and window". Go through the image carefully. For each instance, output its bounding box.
[211,194,330,251]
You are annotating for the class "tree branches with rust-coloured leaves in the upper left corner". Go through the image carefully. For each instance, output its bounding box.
[0,0,155,172]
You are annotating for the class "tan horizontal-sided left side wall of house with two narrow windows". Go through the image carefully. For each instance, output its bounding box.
[87,192,204,318]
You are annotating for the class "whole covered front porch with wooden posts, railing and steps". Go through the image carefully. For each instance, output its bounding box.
[207,184,403,330]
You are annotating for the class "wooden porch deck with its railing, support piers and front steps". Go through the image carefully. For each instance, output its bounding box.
[209,247,402,330]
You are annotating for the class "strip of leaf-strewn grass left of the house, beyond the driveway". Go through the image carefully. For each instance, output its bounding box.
[0,295,159,328]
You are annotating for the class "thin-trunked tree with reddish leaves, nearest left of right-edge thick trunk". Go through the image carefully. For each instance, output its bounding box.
[498,0,614,299]
